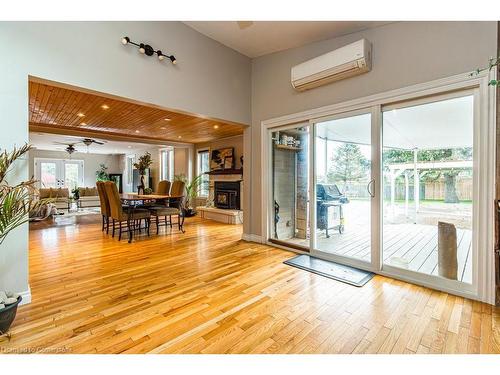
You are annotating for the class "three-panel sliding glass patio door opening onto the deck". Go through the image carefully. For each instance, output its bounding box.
[263,83,491,297]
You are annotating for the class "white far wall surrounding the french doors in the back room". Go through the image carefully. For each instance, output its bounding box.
[29,150,122,187]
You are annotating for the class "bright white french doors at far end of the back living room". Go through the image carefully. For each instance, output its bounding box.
[35,158,84,189]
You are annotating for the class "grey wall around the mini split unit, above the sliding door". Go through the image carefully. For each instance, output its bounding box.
[248,22,497,235]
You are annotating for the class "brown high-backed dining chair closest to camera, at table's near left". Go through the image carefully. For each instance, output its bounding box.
[104,181,151,241]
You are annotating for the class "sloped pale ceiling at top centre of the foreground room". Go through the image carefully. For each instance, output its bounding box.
[184,21,389,58]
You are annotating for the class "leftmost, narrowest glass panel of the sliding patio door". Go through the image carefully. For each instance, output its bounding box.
[269,125,310,251]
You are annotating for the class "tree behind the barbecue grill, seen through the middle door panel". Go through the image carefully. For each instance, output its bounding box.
[327,143,370,191]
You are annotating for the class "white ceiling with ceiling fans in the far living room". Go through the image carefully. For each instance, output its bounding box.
[30,132,171,155]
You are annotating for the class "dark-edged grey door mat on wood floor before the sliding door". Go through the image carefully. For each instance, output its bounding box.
[283,255,375,286]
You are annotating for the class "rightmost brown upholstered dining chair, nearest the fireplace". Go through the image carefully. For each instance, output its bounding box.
[148,181,186,234]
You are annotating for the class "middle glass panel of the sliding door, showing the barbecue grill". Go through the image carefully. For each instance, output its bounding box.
[314,113,374,262]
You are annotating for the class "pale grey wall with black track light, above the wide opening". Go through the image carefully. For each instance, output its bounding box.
[0,22,251,300]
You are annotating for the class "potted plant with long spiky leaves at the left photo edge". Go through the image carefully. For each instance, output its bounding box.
[0,144,45,335]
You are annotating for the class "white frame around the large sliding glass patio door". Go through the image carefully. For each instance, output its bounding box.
[261,69,496,304]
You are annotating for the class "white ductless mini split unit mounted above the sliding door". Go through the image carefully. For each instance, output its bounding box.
[292,39,372,91]
